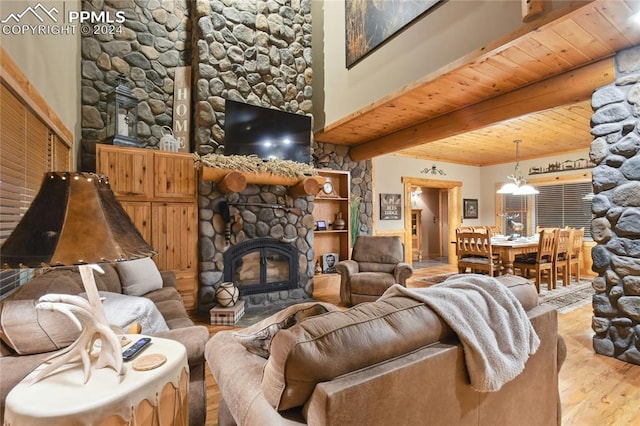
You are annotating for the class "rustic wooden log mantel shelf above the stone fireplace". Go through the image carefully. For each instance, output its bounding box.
[200,166,326,196]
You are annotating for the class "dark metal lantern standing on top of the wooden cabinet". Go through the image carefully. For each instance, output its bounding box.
[107,74,139,147]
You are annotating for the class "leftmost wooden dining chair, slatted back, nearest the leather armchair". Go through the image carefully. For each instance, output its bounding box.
[456,229,501,277]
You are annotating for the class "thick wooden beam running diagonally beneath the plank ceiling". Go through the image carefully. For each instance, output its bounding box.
[349,57,615,161]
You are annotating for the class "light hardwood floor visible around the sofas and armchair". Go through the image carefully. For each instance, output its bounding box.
[197,266,640,426]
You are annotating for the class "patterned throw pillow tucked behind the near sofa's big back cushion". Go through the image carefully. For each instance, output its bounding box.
[233,302,330,359]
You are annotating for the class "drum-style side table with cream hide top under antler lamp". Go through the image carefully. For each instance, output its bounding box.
[4,335,189,426]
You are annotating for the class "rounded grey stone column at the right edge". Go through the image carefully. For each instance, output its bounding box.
[590,47,640,364]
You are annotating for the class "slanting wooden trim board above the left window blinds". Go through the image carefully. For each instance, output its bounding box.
[0,47,73,148]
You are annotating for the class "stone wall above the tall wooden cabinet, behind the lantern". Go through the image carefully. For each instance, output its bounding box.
[81,0,191,147]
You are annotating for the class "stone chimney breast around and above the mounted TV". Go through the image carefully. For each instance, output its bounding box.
[193,0,313,154]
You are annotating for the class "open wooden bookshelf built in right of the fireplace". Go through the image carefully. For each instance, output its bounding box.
[313,170,351,265]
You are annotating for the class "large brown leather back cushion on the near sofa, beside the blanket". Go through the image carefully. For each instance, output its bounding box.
[261,297,453,410]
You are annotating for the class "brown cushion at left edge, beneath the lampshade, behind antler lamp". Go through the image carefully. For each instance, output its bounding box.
[0,300,80,355]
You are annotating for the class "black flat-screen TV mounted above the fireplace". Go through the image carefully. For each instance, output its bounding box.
[224,99,311,164]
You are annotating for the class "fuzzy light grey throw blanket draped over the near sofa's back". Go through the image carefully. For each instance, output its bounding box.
[381,274,540,392]
